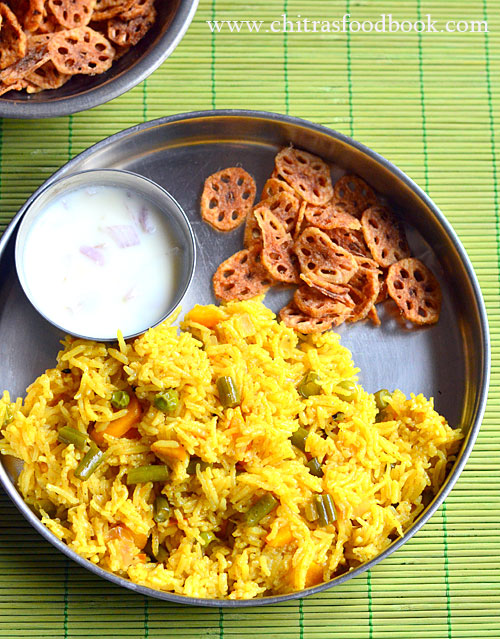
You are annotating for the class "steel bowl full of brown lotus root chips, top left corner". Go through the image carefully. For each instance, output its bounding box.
[0,0,198,119]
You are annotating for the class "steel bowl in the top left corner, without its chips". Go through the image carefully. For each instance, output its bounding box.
[0,0,198,120]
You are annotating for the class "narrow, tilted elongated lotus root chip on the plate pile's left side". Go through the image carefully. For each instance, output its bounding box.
[254,204,299,284]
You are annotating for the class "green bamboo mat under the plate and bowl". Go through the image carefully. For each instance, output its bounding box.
[0,0,500,639]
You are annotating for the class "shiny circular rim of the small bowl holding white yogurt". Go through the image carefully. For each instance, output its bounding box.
[14,169,196,343]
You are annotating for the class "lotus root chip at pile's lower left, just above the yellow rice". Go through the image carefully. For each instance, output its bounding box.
[212,249,273,302]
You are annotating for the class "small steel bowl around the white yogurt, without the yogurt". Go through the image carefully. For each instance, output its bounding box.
[15,169,196,342]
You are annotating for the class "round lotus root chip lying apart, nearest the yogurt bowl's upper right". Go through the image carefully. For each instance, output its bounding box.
[201,167,256,231]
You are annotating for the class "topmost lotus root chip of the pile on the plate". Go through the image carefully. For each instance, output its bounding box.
[275,146,333,205]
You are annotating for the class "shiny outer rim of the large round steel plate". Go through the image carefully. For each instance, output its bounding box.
[0,109,491,608]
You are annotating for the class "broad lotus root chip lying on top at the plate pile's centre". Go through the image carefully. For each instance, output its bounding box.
[295,227,358,292]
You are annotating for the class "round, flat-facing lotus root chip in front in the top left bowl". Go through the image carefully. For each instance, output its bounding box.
[47,27,115,75]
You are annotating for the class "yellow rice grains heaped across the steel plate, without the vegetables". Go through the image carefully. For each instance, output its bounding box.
[0,299,462,599]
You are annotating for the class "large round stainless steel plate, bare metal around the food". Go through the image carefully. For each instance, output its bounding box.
[0,111,489,607]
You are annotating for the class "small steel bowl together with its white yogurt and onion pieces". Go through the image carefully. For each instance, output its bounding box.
[16,170,195,341]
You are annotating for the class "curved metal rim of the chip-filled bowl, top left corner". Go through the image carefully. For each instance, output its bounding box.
[0,0,199,120]
